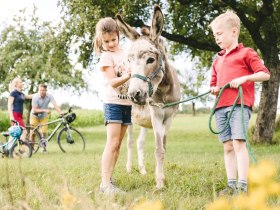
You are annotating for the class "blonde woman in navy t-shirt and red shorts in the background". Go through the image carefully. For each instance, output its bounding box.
[8,77,32,140]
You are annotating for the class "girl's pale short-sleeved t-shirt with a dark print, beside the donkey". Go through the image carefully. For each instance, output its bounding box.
[98,49,131,105]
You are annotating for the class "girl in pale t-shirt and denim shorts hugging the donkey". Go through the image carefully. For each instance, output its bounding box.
[93,17,131,194]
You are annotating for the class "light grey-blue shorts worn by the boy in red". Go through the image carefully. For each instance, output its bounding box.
[215,105,251,142]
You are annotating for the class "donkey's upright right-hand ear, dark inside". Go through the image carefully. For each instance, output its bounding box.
[150,4,164,42]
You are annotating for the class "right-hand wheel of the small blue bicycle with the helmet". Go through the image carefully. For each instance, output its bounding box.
[10,140,32,158]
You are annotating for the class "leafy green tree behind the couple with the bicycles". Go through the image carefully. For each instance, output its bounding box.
[0,8,86,123]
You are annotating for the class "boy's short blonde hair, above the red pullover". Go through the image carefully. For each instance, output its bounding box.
[209,10,240,34]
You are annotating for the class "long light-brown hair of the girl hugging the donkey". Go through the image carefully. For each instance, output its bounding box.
[92,17,120,55]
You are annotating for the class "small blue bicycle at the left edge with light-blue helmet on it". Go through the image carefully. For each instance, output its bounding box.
[0,120,32,158]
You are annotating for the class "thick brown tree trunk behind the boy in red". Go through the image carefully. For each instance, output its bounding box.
[253,53,280,143]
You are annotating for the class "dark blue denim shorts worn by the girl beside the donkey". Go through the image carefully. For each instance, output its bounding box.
[104,104,131,125]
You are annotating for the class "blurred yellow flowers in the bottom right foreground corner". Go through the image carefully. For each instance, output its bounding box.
[206,161,280,210]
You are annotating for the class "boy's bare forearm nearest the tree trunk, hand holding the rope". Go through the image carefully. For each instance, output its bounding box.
[230,71,270,88]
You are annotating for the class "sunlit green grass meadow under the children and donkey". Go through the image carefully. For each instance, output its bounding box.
[0,115,280,209]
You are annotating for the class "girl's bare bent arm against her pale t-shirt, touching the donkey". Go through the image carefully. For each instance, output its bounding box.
[103,66,130,88]
